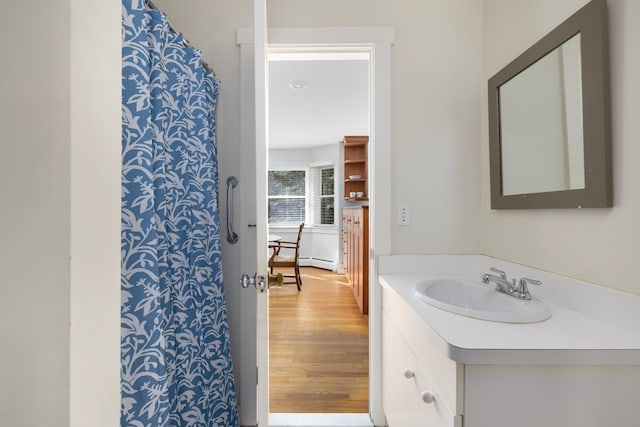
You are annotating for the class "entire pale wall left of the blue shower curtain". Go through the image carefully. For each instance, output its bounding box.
[0,0,121,427]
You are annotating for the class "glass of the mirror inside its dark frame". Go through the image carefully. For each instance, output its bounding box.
[499,34,584,196]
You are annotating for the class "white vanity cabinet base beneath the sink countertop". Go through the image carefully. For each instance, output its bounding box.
[382,286,640,427]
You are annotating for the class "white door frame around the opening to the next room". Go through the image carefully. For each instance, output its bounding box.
[237,27,394,427]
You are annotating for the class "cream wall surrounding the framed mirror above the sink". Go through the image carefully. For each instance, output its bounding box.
[481,0,640,294]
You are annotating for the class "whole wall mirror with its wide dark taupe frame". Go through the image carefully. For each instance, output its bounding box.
[489,0,612,209]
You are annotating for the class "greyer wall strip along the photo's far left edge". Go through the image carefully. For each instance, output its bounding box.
[0,1,70,427]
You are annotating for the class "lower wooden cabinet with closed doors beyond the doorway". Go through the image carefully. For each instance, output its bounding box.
[342,206,369,314]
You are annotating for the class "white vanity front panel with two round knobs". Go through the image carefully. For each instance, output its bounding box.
[382,314,462,427]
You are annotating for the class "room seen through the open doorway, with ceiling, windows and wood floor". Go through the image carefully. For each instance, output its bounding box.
[267,45,374,414]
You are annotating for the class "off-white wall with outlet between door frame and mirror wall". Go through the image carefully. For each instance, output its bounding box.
[268,0,482,254]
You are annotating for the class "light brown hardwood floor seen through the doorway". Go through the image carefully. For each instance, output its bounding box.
[269,267,369,413]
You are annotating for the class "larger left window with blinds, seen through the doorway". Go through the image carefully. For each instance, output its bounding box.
[267,170,306,225]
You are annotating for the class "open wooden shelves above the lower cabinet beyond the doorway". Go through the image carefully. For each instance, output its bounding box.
[342,136,369,201]
